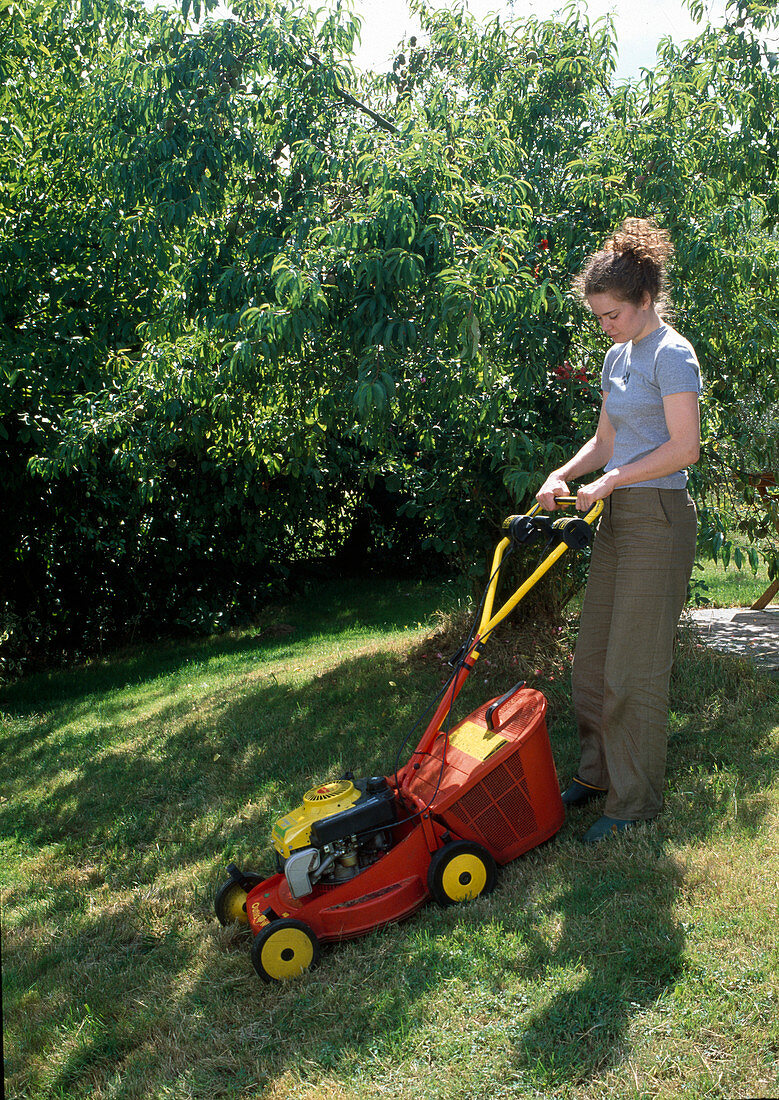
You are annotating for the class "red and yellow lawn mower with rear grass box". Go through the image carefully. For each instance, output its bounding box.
[215,497,603,981]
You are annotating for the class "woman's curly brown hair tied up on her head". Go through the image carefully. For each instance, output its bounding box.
[573,218,673,309]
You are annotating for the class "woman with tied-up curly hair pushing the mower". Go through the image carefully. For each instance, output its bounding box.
[537,218,701,843]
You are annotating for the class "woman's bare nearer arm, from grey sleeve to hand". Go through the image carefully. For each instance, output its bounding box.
[577,393,701,512]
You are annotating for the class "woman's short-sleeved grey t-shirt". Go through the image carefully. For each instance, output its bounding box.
[601,325,701,488]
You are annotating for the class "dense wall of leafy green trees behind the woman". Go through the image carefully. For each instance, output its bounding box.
[0,0,779,664]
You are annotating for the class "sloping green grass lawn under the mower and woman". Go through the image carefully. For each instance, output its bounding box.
[0,567,779,1100]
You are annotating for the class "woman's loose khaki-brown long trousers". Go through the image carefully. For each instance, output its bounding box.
[572,488,698,821]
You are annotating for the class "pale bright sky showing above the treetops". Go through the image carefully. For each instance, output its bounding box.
[343,0,725,79]
